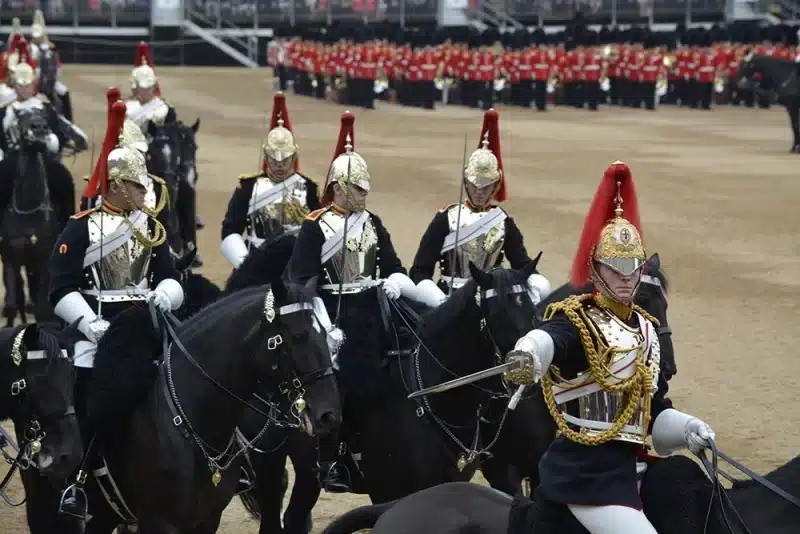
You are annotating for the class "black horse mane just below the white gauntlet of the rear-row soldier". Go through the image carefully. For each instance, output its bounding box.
[224,234,296,294]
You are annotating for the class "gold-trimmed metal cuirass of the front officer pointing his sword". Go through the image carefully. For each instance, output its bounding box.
[554,306,661,445]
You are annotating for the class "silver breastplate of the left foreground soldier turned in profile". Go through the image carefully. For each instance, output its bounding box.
[88,212,152,290]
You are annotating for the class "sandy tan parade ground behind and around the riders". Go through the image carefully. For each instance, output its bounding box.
[0,65,800,534]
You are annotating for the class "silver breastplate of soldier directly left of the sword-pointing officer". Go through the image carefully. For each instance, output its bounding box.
[442,204,506,278]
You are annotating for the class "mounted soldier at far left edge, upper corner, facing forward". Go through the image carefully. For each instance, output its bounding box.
[3,38,89,161]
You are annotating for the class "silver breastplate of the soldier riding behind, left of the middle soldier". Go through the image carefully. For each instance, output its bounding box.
[247,177,309,242]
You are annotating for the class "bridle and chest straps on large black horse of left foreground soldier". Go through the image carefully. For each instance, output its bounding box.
[155,289,334,485]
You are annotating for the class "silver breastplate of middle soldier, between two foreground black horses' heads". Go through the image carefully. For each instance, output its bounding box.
[319,210,378,284]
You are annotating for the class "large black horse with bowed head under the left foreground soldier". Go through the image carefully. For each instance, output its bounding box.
[71,279,341,534]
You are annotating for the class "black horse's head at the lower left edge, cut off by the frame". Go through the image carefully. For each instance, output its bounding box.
[0,324,83,481]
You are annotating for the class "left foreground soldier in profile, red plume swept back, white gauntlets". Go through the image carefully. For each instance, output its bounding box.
[50,102,184,517]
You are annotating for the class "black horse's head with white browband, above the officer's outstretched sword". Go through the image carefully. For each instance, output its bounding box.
[469,262,541,354]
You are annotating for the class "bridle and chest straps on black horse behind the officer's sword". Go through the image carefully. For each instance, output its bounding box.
[389,276,535,471]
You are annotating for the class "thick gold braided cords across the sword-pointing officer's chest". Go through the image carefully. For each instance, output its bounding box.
[542,294,657,446]
